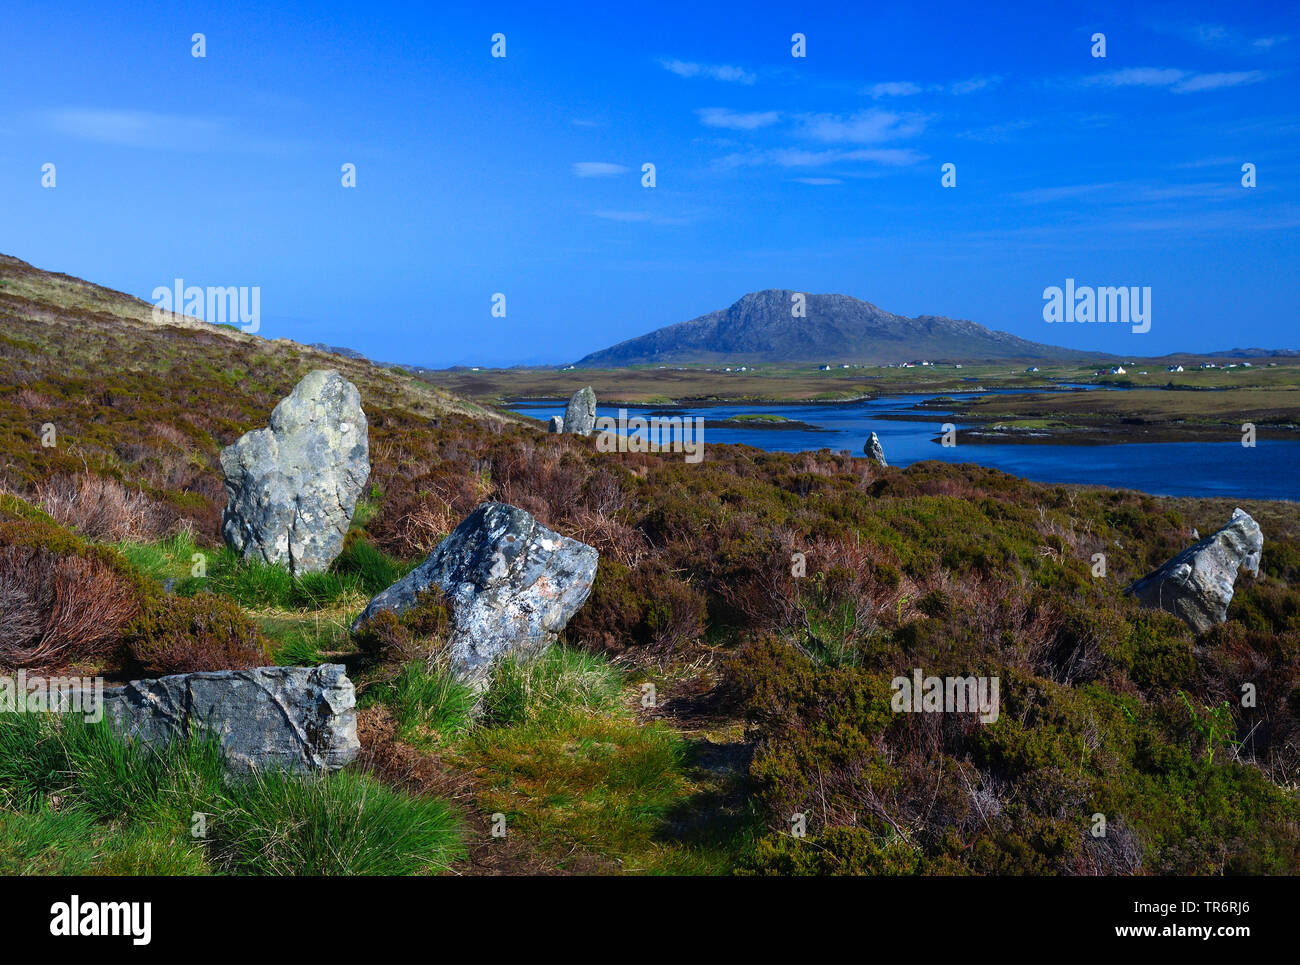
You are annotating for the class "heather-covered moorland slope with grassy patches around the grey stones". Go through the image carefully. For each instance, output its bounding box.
[0,274,1300,874]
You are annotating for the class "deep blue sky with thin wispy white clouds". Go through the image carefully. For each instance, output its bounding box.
[0,1,1300,365]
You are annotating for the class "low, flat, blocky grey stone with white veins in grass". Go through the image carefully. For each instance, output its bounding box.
[66,663,361,773]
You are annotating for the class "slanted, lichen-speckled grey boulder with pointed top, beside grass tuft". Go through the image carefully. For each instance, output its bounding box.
[354,502,599,689]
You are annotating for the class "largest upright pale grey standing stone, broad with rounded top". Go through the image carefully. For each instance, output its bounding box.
[221,369,371,575]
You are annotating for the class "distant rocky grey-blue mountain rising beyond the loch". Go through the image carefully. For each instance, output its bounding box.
[575,289,1105,368]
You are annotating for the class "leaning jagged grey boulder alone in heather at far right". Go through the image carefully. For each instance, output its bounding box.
[1125,510,1264,633]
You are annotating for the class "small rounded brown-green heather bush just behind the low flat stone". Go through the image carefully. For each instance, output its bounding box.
[126,593,269,675]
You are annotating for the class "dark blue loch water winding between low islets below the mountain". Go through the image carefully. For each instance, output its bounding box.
[514,393,1300,499]
